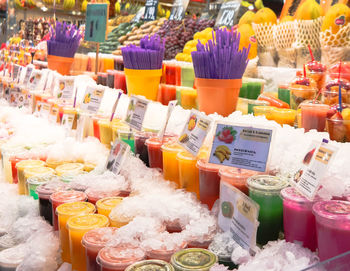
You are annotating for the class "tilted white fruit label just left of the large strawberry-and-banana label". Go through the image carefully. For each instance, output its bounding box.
[179,109,212,156]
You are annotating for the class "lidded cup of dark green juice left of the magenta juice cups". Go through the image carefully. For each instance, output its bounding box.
[247,175,288,245]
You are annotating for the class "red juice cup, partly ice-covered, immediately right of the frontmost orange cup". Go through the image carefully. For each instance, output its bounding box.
[82,227,118,271]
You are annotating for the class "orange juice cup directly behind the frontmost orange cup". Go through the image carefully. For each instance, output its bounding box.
[56,202,95,263]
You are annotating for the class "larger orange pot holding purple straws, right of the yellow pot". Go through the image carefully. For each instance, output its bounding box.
[195,78,242,117]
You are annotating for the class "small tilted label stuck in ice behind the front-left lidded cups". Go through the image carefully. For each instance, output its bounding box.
[106,139,130,174]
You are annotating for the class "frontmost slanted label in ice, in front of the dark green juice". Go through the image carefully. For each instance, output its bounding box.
[218,182,259,251]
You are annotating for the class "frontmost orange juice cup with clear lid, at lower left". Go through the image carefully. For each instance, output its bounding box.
[67,214,109,271]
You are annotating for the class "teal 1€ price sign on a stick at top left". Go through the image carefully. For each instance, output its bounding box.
[84,3,109,42]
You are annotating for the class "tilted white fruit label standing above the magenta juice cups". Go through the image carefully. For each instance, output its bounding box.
[292,140,338,200]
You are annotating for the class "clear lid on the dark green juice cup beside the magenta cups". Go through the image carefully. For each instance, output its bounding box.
[247,175,289,192]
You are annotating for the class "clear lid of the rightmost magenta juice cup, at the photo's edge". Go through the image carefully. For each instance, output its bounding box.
[312,200,350,222]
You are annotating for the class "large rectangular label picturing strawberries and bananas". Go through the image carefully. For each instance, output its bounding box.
[209,123,274,172]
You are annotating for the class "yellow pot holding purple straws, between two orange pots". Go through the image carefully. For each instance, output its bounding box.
[124,68,162,101]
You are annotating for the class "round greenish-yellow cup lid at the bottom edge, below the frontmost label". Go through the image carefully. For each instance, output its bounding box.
[171,248,218,271]
